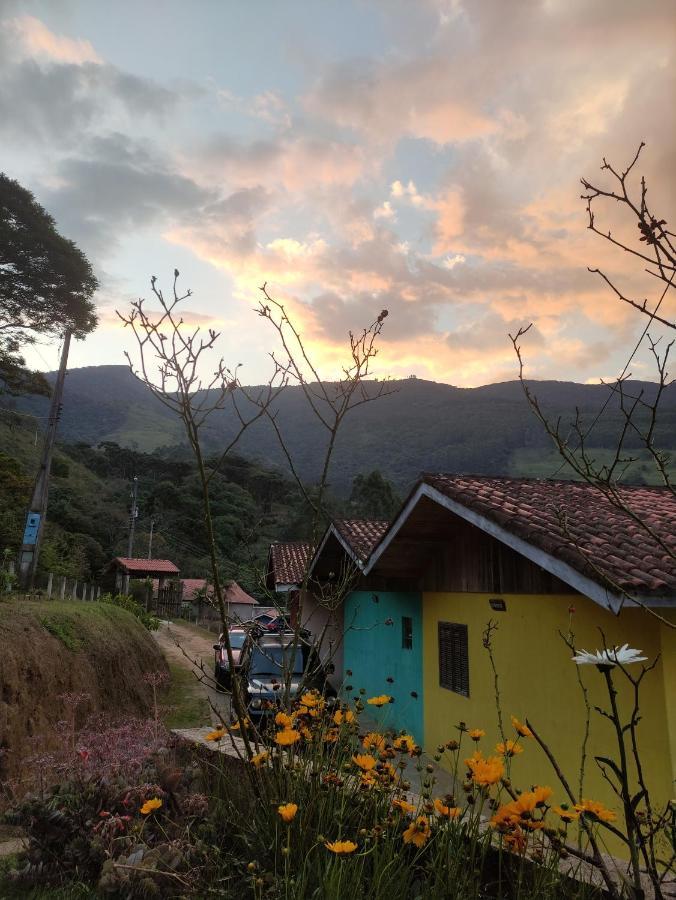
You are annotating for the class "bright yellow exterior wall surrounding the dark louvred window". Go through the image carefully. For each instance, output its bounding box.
[422,592,676,828]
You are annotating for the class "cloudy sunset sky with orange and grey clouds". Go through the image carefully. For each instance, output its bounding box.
[0,0,676,386]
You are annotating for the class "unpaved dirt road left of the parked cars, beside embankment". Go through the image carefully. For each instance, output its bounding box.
[153,622,230,724]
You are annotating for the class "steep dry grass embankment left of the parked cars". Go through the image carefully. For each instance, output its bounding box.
[0,598,167,777]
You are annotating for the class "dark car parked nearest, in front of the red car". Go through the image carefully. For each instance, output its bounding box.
[240,632,335,721]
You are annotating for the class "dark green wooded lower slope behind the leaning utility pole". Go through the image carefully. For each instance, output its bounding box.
[0,411,298,592]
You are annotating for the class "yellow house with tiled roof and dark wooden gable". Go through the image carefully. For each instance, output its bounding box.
[364,475,676,828]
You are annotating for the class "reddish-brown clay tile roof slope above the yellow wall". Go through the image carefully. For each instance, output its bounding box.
[422,475,676,597]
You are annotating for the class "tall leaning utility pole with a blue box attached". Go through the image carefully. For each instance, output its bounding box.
[19,329,71,590]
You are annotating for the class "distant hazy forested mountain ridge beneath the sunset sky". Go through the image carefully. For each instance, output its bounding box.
[9,366,676,493]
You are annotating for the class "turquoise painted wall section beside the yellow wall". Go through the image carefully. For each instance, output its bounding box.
[344,591,423,742]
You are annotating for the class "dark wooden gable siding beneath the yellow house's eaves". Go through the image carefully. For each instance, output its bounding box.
[365,497,576,594]
